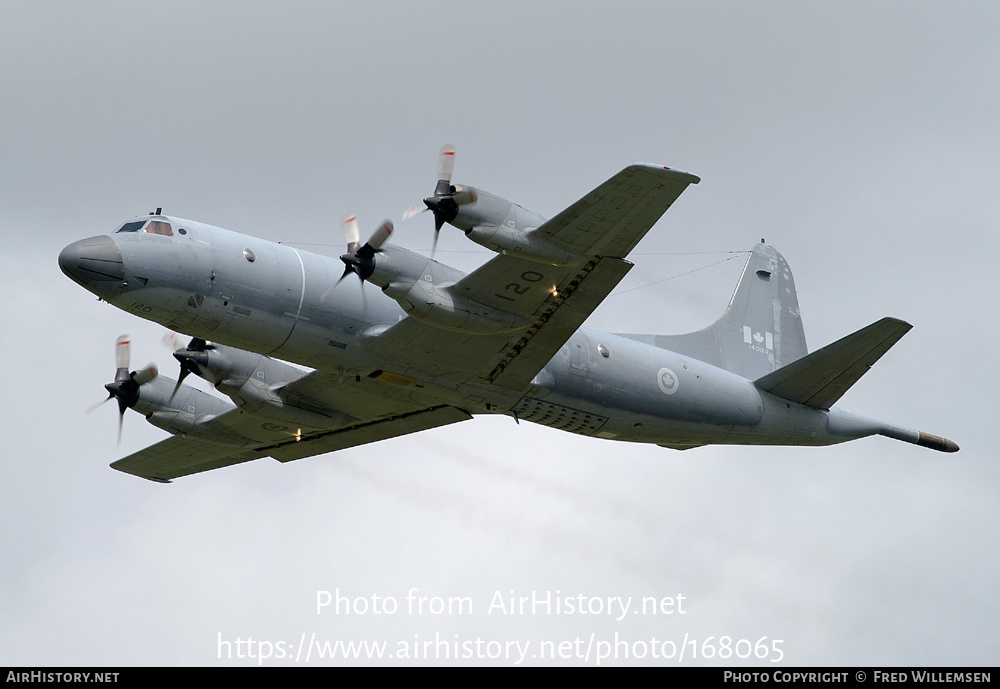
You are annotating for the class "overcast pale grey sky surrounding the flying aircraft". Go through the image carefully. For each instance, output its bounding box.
[0,0,1000,666]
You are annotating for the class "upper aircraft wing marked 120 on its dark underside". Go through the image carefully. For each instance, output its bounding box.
[376,164,699,390]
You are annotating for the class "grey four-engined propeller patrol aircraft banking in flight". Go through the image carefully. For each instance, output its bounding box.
[59,146,958,482]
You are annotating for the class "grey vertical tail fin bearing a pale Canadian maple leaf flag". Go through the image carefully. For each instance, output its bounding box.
[629,242,808,380]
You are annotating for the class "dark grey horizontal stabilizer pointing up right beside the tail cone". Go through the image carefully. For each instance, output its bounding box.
[754,318,913,409]
